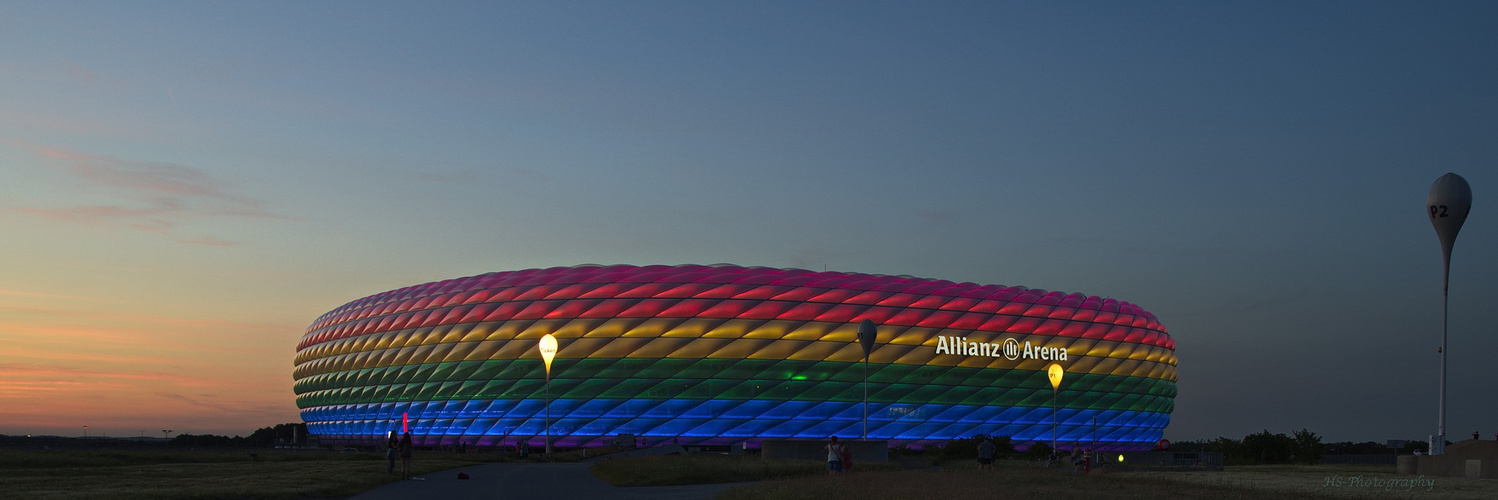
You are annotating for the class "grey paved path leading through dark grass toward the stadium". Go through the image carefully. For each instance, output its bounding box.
[351,463,749,500]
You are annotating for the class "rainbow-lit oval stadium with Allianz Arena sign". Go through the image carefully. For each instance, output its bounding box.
[294,265,1176,449]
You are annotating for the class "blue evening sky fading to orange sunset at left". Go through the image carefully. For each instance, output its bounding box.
[0,1,1498,440]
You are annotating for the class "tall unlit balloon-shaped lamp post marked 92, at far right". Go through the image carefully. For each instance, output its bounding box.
[1425,174,1473,455]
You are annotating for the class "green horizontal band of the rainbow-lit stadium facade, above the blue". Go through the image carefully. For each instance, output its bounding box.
[295,358,1176,413]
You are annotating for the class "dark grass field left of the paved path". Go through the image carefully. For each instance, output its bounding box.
[0,449,493,500]
